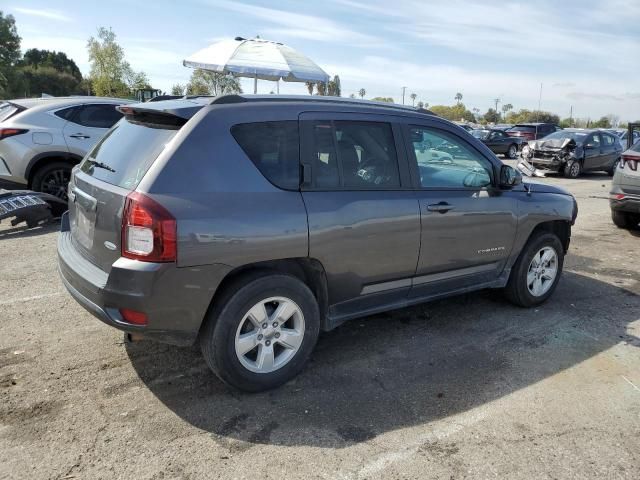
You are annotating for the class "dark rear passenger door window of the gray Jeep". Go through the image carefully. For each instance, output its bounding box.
[311,121,400,190]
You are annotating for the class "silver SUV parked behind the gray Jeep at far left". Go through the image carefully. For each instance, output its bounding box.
[0,97,131,199]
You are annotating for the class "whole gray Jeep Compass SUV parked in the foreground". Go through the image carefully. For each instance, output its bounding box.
[58,95,577,391]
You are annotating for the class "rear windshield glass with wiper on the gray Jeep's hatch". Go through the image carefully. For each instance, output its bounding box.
[80,120,178,190]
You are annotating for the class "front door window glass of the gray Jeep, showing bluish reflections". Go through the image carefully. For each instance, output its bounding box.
[410,126,492,189]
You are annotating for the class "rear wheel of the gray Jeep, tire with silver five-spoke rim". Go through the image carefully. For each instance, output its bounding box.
[200,273,320,392]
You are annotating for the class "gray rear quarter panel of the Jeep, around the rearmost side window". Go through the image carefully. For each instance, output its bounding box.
[138,105,309,267]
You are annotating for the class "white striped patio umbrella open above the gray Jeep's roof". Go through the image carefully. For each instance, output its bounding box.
[182,37,329,93]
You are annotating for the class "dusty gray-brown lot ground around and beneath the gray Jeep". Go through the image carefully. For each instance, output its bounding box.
[0,171,640,479]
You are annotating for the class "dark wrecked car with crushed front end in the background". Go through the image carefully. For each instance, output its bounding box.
[522,129,622,178]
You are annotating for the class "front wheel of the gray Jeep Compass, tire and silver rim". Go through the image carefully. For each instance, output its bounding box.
[505,233,564,308]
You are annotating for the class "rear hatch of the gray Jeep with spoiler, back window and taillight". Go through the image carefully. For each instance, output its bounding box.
[69,100,203,272]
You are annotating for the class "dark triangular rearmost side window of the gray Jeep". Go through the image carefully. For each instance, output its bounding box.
[231,121,300,190]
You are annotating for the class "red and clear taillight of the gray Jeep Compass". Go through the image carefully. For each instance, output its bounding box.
[122,192,177,262]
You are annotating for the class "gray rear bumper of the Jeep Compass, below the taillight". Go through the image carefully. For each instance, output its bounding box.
[58,214,230,345]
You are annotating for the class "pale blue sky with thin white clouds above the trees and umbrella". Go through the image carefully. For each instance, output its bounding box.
[8,0,640,120]
